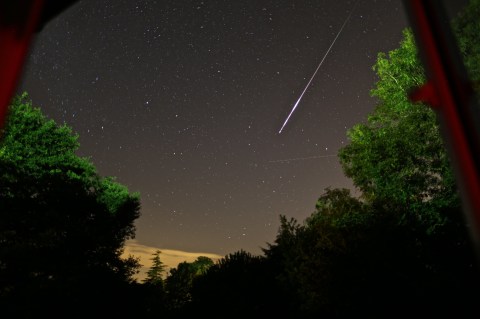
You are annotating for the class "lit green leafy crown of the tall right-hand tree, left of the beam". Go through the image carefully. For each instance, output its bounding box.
[339,30,460,231]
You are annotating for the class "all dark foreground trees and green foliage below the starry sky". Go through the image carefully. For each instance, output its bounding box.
[0,1,480,318]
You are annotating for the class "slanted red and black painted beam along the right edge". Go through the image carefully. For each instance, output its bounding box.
[404,0,480,256]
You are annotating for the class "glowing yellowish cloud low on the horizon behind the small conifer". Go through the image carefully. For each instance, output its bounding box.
[122,240,224,281]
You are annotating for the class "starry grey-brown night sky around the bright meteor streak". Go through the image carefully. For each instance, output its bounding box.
[19,0,407,255]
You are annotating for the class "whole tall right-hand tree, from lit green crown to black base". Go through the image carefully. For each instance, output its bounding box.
[339,1,480,314]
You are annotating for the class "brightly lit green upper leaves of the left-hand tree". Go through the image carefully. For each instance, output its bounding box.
[0,93,95,185]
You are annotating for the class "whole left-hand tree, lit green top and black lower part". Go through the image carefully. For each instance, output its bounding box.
[0,93,140,316]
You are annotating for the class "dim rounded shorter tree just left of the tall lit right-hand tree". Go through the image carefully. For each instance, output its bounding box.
[265,188,376,318]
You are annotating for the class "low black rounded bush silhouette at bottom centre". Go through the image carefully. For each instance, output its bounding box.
[189,250,285,318]
